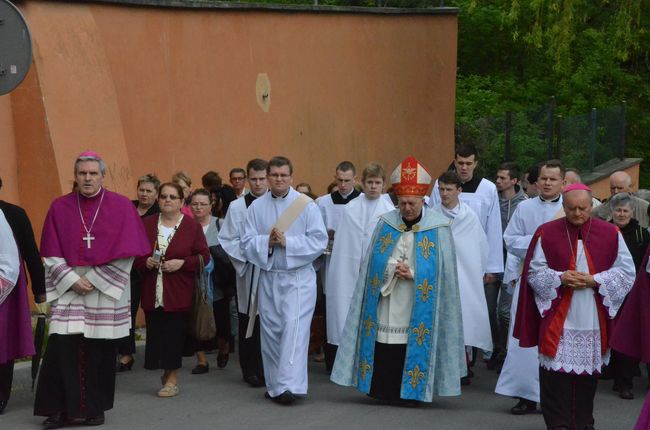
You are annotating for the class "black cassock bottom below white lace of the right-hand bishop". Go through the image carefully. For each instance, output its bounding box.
[539,367,598,430]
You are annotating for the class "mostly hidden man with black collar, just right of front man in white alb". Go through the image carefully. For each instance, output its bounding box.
[316,161,361,372]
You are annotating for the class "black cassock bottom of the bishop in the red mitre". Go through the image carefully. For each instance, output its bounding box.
[368,342,406,402]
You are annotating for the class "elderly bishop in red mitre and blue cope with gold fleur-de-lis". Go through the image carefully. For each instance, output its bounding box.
[331,157,467,405]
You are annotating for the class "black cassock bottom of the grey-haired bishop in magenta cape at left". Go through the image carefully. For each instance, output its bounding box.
[34,334,116,418]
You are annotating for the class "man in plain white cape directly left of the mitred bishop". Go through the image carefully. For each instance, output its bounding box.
[326,163,394,354]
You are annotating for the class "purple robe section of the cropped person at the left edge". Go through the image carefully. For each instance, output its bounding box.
[0,258,34,364]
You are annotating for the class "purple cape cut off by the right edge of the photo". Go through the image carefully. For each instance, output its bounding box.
[610,247,650,363]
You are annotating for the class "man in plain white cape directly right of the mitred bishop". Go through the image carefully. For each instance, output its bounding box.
[433,171,492,373]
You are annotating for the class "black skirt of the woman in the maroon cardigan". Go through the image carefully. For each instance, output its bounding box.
[144,308,187,370]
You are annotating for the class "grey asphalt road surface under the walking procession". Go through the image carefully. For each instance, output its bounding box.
[0,346,647,430]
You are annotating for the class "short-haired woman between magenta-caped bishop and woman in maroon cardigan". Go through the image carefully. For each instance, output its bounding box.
[117,173,160,372]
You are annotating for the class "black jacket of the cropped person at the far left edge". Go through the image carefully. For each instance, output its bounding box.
[0,200,45,298]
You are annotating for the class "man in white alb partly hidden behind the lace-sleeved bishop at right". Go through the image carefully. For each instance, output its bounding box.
[495,160,565,415]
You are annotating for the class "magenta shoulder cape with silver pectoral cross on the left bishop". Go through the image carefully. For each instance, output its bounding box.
[41,188,151,267]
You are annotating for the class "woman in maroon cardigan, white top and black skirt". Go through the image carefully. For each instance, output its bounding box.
[135,183,210,397]
